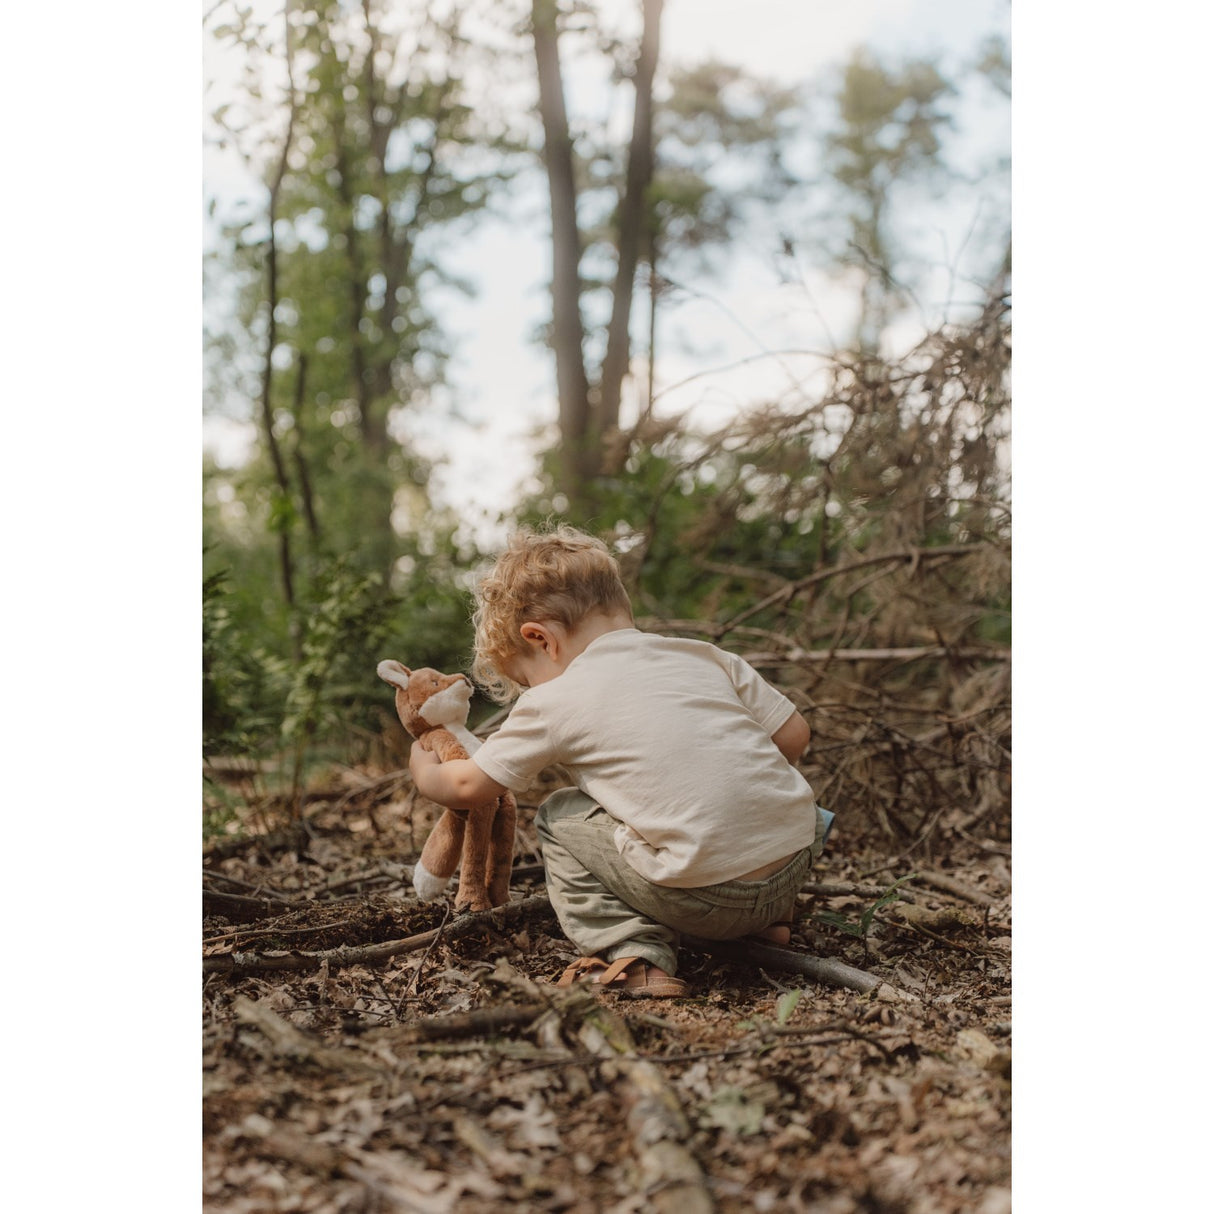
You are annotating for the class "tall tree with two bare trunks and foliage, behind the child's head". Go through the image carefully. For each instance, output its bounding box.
[531,0,798,510]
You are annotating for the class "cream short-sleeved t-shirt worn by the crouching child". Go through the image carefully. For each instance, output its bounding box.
[472,628,817,889]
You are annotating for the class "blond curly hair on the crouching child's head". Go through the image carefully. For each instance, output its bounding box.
[472,523,632,704]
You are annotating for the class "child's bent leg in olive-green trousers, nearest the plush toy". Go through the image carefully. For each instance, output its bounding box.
[535,788,679,974]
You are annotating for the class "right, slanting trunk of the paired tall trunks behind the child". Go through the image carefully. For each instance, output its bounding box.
[595,0,663,435]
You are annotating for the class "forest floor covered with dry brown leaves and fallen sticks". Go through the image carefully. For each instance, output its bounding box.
[202,768,1011,1214]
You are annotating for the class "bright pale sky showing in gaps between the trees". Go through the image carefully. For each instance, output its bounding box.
[204,0,1010,539]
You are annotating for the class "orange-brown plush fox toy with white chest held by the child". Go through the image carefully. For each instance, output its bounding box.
[375,660,518,911]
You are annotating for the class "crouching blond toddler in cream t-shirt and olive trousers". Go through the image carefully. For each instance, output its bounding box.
[409,526,828,998]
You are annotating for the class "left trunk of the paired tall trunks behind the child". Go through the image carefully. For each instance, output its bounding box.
[532,0,594,501]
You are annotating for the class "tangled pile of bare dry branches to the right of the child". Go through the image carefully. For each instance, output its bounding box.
[629,297,1011,855]
